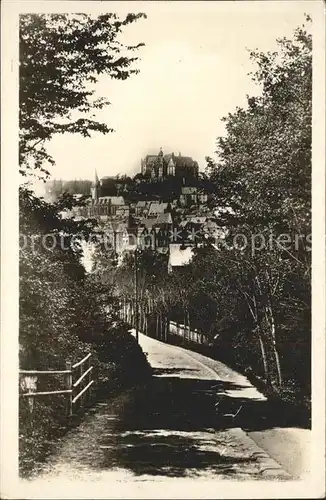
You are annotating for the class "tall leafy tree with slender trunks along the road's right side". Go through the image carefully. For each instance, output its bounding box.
[207,18,312,396]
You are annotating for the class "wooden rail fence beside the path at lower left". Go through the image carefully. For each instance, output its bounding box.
[19,353,94,416]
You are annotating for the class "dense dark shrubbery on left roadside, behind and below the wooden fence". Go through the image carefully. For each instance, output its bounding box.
[19,191,150,474]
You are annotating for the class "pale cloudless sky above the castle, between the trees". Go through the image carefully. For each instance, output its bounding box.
[38,2,309,179]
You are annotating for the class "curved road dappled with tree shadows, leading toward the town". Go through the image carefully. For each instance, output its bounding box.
[23,335,309,498]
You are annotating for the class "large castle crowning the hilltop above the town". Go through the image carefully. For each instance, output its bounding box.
[141,148,198,180]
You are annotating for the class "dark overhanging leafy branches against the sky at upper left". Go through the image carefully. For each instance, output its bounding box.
[19,13,146,175]
